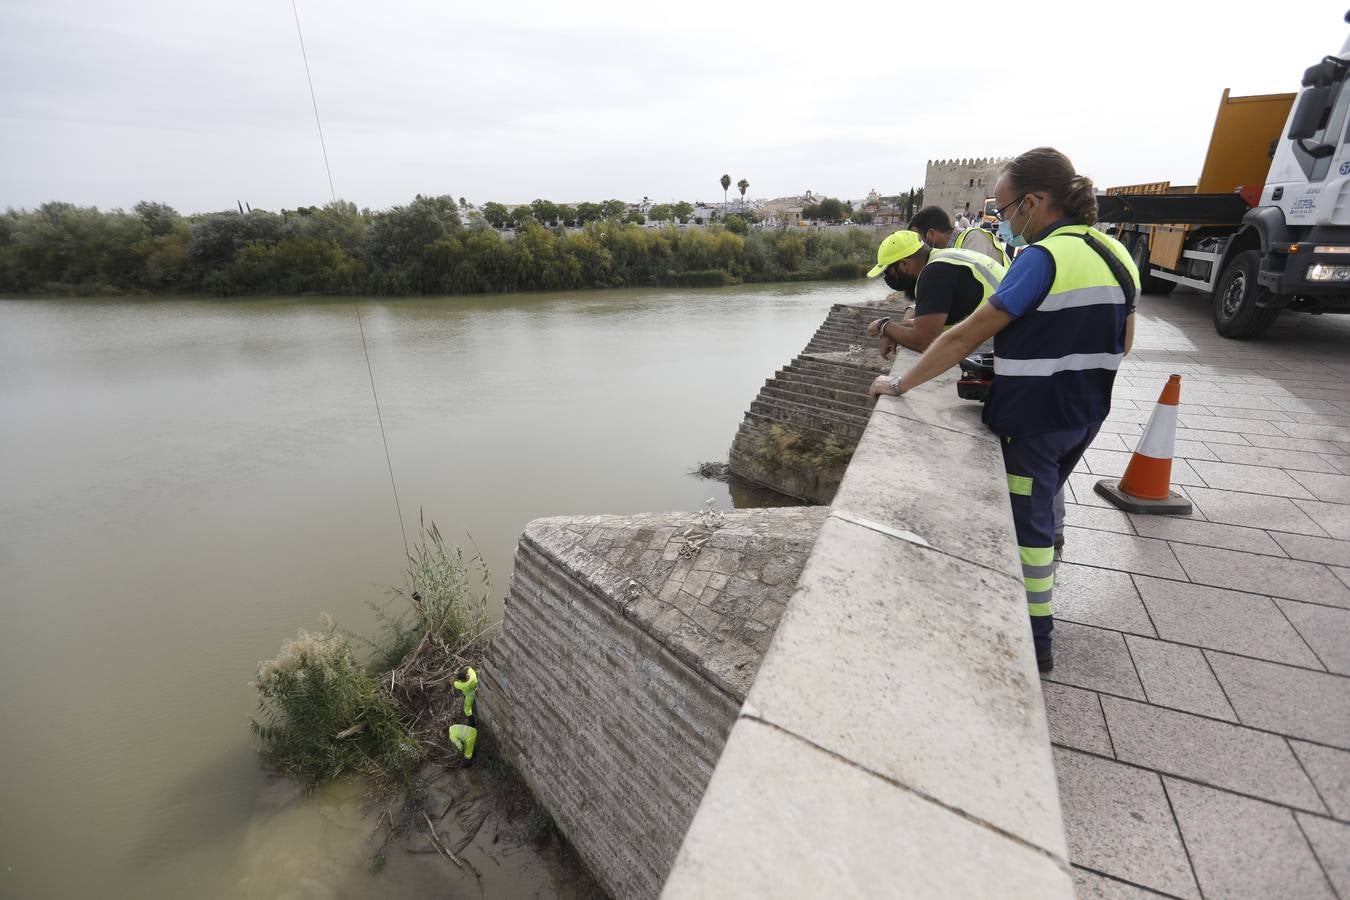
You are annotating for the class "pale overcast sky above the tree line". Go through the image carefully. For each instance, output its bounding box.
[0,0,1347,212]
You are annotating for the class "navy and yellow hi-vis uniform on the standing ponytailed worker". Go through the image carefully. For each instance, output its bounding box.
[984,220,1139,656]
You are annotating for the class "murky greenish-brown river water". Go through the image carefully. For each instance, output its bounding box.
[0,283,875,897]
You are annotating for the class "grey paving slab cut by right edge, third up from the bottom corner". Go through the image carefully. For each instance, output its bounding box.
[1204,650,1350,750]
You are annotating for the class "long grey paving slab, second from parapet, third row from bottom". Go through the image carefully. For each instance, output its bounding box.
[1102,696,1327,814]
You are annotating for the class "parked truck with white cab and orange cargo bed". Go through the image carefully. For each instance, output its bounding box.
[1098,15,1350,337]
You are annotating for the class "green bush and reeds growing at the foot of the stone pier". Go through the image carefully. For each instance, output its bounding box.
[251,525,489,797]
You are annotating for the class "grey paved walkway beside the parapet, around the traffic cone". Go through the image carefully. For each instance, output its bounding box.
[1044,294,1350,900]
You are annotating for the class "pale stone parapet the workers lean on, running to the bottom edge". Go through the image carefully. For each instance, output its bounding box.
[663,351,1073,900]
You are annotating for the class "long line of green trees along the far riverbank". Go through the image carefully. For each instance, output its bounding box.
[0,196,875,296]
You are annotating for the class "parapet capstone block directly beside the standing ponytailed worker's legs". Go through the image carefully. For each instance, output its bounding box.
[834,395,1021,578]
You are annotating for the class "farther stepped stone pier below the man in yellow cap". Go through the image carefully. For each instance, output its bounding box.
[729,300,905,503]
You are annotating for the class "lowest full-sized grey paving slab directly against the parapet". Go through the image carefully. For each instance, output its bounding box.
[1054,749,1200,897]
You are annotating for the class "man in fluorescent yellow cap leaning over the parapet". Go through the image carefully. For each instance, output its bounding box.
[867,231,1007,359]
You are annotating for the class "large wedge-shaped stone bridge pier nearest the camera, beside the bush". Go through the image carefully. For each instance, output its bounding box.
[479,509,826,899]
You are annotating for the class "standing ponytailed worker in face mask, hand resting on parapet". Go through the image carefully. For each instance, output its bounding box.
[872,147,1139,672]
